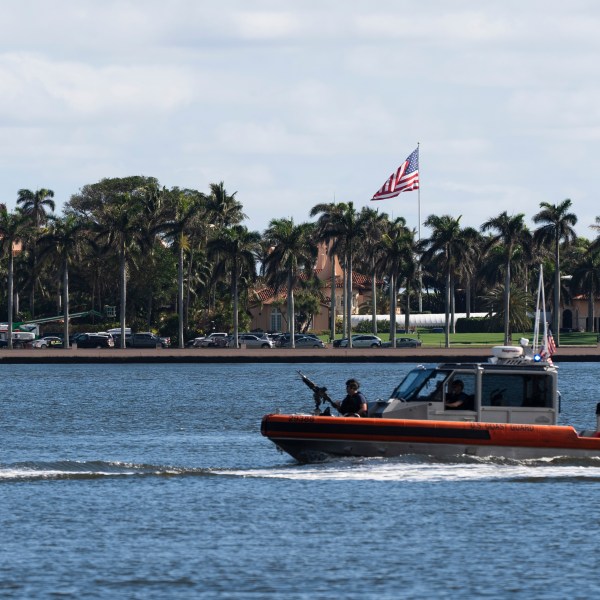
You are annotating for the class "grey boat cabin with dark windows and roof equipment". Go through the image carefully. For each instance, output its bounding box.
[369,347,560,425]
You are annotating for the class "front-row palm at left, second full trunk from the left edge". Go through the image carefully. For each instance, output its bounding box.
[39,214,86,348]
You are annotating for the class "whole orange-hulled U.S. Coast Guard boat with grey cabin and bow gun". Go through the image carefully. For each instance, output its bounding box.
[261,340,600,462]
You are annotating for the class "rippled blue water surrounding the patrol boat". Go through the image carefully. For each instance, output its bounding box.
[0,363,600,599]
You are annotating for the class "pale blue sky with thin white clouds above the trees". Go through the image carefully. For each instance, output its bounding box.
[0,0,600,239]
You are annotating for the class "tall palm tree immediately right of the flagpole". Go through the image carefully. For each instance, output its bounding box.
[419,215,466,348]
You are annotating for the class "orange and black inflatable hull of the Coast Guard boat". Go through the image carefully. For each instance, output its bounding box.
[261,414,600,462]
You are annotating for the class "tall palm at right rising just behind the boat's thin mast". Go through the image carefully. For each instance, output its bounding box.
[533,198,577,346]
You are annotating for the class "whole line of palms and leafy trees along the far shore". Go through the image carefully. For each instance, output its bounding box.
[0,176,600,347]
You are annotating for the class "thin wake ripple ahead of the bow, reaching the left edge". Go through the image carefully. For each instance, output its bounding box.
[0,460,214,483]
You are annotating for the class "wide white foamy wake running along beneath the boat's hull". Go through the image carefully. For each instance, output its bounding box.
[221,455,600,482]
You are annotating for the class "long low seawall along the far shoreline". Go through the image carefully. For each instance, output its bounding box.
[0,346,600,365]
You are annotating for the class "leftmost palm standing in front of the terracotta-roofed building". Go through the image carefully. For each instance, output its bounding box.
[265,219,317,348]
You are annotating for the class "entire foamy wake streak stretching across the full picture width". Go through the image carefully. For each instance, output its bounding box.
[0,455,600,484]
